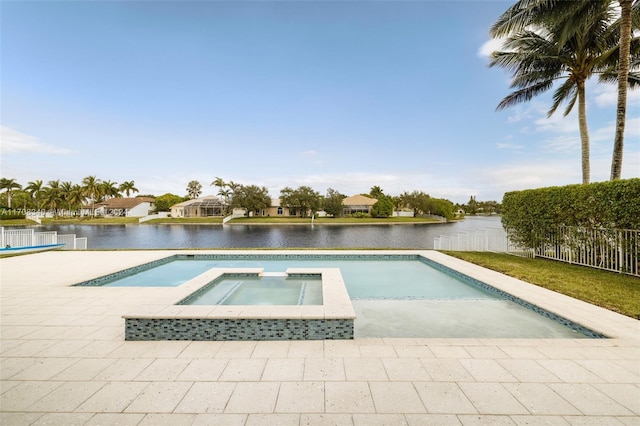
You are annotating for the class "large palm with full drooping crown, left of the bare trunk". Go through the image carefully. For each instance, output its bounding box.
[490,0,618,183]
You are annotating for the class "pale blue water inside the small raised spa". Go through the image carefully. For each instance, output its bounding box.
[180,275,322,305]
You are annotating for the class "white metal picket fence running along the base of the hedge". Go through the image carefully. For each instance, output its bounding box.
[433,226,640,276]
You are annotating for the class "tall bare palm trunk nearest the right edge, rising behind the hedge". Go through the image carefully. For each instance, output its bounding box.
[611,0,633,180]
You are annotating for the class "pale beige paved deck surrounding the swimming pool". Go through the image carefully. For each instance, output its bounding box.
[0,250,640,426]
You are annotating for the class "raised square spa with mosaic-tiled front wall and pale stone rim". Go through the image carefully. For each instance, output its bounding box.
[124,268,356,340]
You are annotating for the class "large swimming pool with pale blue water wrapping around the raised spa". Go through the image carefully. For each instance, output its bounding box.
[77,254,604,338]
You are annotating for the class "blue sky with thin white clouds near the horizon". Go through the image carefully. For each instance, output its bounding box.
[0,1,640,203]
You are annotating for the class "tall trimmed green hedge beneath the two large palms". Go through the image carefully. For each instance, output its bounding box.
[502,179,640,248]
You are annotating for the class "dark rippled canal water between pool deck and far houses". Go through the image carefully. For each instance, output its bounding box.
[37,216,502,249]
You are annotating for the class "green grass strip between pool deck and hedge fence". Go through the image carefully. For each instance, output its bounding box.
[445,251,640,318]
